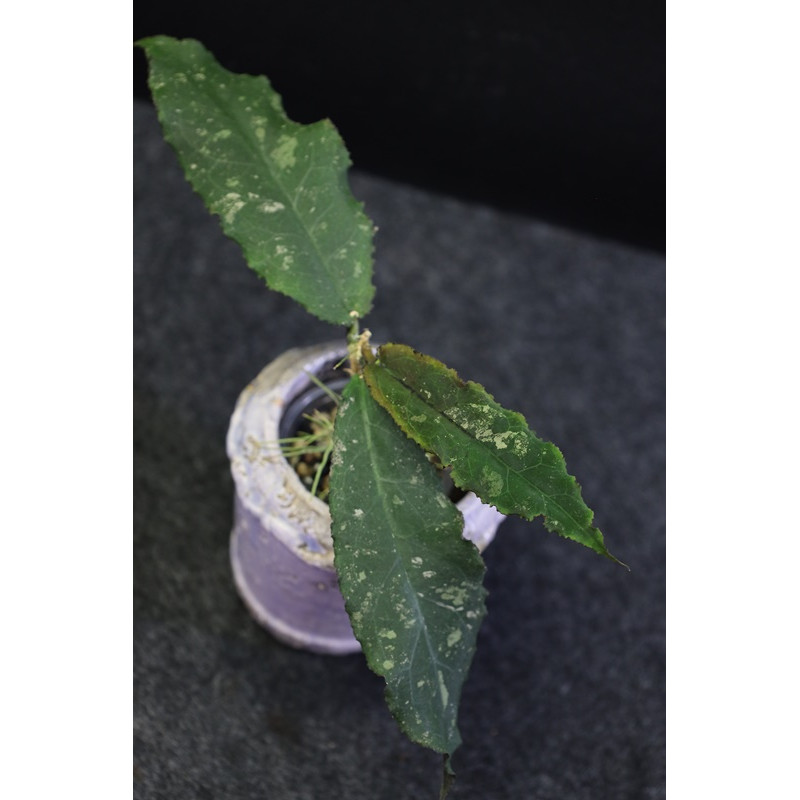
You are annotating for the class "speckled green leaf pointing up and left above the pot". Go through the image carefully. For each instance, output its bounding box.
[139,36,374,325]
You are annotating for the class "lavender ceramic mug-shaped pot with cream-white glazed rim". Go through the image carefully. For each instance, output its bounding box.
[227,343,505,654]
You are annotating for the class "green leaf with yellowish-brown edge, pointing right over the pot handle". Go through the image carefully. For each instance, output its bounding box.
[364,344,622,563]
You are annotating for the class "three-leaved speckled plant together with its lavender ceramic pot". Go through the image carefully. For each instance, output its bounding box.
[139,36,621,794]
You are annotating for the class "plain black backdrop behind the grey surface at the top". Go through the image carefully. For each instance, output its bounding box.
[134,0,665,250]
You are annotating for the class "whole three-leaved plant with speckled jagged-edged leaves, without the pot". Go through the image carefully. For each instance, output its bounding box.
[139,36,620,793]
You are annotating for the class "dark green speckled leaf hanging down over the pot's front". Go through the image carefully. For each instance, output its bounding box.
[330,376,485,754]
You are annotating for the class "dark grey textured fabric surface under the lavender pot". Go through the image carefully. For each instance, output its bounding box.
[134,102,665,800]
